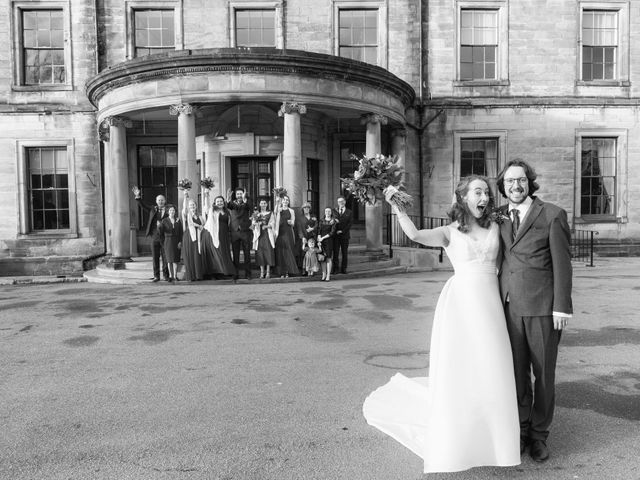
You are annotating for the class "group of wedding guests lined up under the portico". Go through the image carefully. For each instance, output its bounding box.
[132,187,353,282]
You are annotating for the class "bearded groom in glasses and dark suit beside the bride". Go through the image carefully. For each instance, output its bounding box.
[497,159,573,462]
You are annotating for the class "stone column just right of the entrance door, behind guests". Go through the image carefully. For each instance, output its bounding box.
[278,102,307,207]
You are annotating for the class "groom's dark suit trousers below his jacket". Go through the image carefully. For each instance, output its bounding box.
[505,302,561,440]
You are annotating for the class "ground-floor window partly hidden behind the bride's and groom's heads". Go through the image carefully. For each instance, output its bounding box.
[451,130,507,196]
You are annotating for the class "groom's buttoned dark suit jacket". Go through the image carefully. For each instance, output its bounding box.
[499,197,573,317]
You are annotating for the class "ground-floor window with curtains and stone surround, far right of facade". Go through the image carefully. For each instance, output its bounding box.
[574,129,628,223]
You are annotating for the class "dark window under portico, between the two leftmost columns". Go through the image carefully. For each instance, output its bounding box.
[137,145,182,228]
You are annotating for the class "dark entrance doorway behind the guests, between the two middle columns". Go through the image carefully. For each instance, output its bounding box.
[231,157,276,210]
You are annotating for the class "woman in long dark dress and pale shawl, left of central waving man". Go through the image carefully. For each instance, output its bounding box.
[202,190,236,279]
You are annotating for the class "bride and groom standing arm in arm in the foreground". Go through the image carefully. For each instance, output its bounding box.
[363,159,573,473]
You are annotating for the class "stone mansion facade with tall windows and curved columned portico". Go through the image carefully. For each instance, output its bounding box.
[0,0,640,275]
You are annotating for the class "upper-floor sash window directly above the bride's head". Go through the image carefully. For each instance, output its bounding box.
[460,10,498,80]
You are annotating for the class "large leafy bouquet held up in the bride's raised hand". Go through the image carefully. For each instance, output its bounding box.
[340,154,412,211]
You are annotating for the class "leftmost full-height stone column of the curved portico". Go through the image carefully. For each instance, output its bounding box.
[105,117,131,268]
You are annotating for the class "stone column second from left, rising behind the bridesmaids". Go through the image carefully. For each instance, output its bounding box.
[169,103,200,202]
